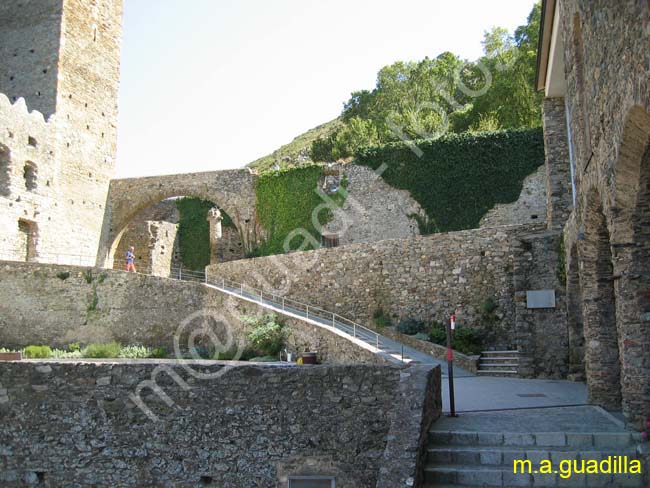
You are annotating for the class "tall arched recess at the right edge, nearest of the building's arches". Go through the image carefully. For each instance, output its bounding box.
[613,106,650,425]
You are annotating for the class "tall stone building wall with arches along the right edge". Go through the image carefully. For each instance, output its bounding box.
[547,0,650,427]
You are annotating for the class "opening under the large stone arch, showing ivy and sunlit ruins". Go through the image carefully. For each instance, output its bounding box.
[110,197,245,276]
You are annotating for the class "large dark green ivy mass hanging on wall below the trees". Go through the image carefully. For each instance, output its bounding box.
[356,129,544,232]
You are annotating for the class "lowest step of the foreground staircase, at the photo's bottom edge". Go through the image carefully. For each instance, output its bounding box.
[424,465,644,488]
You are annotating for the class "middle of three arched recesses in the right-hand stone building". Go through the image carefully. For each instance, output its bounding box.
[579,189,621,410]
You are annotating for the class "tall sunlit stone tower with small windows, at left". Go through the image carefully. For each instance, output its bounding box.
[0,0,122,264]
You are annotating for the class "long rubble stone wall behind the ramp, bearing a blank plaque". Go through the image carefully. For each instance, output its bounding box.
[208,226,566,358]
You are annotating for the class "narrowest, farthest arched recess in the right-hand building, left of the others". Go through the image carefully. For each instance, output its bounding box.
[566,244,585,378]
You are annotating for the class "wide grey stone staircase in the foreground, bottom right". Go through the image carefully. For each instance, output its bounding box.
[425,430,645,488]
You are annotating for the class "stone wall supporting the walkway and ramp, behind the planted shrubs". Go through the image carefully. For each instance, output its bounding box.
[0,262,394,364]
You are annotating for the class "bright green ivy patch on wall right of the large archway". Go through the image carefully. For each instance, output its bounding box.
[256,165,332,256]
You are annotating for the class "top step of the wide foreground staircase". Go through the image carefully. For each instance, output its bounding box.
[428,429,641,449]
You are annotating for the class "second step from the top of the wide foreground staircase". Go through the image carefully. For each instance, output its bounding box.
[427,446,636,469]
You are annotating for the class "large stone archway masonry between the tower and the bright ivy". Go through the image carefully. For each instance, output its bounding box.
[97,169,261,266]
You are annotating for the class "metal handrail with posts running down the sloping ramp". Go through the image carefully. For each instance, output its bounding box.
[205,275,381,349]
